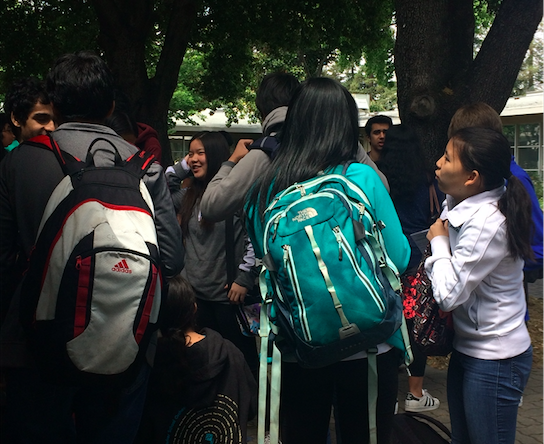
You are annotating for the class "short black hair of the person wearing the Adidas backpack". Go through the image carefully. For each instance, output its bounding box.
[47,51,115,122]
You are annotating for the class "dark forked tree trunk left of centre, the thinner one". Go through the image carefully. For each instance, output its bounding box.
[92,0,196,165]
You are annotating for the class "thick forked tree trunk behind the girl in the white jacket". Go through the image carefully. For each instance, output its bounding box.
[395,0,542,167]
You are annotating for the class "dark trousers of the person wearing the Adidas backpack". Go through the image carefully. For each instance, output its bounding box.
[2,364,151,444]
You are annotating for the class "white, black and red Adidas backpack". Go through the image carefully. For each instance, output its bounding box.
[20,136,162,385]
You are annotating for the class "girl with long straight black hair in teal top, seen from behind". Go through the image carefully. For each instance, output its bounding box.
[246,78,410,444]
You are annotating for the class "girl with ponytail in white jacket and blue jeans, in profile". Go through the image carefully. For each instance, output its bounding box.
[425,128,532,444]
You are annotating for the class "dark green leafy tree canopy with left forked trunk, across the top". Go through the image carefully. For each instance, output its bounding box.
[0,0,542,162]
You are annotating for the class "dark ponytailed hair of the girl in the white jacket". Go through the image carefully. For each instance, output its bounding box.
[452,127,534,259]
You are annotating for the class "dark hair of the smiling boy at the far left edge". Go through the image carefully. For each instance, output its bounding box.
[4,77,49,124]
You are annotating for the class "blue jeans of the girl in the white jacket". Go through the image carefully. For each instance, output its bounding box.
[448,347,533,444]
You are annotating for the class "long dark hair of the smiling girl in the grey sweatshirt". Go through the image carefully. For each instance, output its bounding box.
[179,131,230,233]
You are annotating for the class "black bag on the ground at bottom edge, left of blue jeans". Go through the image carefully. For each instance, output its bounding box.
[391,412,451,444]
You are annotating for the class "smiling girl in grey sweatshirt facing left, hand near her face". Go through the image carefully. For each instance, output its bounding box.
[166,131,258,375]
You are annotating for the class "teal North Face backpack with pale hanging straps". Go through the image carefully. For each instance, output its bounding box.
[255,164,411,442]
